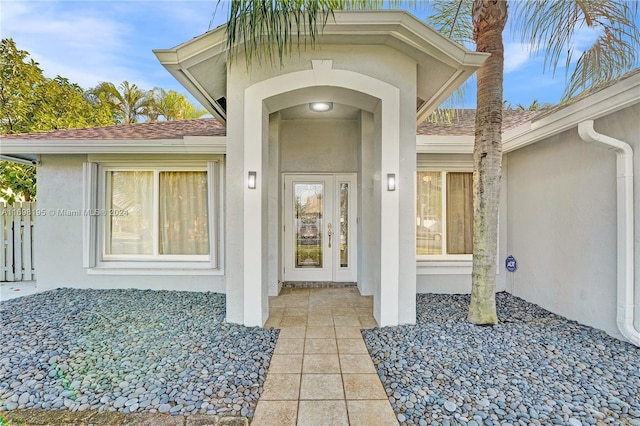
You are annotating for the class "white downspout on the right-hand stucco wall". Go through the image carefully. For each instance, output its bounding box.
[578,120,640,346]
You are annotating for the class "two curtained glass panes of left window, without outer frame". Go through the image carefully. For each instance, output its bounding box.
[104,169,209,260]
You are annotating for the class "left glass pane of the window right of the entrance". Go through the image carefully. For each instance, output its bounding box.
[416,172,442,255]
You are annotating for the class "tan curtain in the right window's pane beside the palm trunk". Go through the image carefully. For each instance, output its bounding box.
[447,173,473,254]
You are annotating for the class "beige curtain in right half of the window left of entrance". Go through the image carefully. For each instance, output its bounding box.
[159,172,209,255]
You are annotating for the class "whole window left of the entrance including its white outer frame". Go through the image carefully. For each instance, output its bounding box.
[85,162,218,268]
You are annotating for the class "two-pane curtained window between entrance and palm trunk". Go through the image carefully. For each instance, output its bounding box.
[416,171,473,256]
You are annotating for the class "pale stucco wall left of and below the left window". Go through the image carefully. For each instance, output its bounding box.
[34,155,225,293]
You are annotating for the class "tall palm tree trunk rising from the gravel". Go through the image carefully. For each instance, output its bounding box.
[468,0,507,325]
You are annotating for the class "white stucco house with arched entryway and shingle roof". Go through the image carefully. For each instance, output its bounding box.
[1,11,640,344]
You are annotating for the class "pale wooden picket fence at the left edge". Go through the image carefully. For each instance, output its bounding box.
[0,202,36,281]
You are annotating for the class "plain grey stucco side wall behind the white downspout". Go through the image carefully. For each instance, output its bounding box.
[507,106,640,337]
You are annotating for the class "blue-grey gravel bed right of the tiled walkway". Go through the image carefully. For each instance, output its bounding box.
[363,293,640,426]
